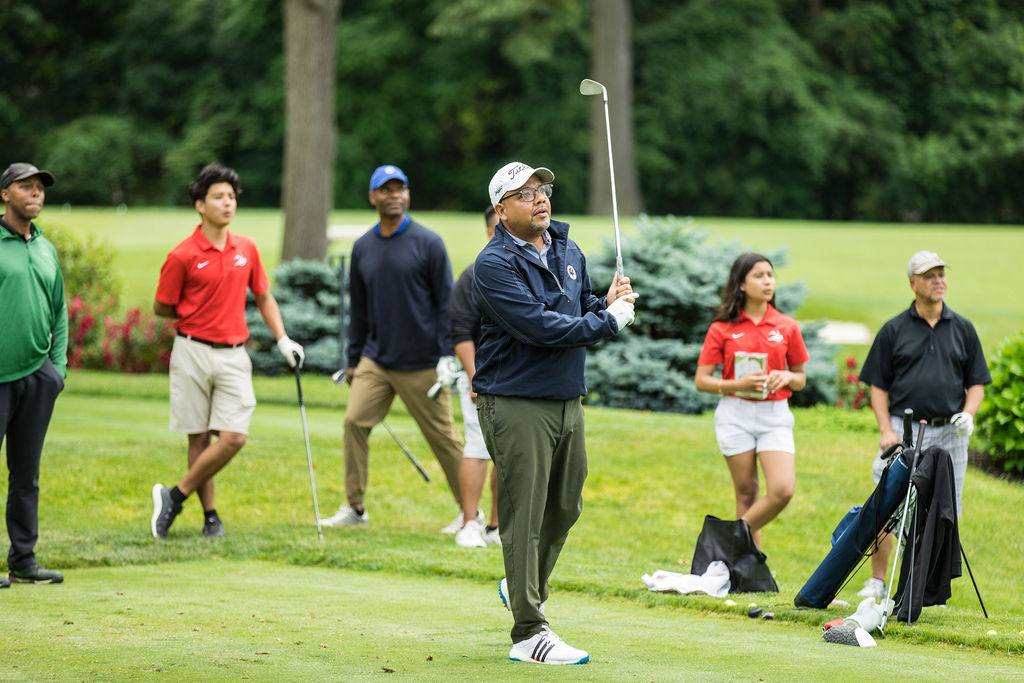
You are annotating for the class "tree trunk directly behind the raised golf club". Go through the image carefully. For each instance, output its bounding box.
[587,0,643,216]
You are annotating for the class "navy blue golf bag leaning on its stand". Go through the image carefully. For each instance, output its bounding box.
[793,411,914,609]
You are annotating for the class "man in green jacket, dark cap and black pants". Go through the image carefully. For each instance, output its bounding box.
[0,163,68,588]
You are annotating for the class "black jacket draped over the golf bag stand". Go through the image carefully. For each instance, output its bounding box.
[895,445,962,623]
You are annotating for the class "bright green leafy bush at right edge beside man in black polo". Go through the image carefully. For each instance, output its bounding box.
[977,331,1024,472]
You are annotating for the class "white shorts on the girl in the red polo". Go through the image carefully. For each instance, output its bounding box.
[715,396,797,456]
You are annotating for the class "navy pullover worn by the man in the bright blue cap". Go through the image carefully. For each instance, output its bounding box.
[347,219,453,370]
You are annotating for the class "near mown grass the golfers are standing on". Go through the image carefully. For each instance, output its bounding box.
[0,372,1024,681]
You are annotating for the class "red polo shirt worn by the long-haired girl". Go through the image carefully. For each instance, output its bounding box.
[697,304,810,400]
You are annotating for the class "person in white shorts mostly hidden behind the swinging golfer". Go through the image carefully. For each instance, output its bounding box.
[452,206,502,548]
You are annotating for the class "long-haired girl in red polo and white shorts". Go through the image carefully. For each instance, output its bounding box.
[695,254,808,547]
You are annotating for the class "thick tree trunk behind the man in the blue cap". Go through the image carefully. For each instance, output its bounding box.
[281,0,341,261]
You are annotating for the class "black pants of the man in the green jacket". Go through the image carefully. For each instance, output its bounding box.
[0,358,63,569]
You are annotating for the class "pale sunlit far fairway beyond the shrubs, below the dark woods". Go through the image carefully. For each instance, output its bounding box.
[40,208,1024,354]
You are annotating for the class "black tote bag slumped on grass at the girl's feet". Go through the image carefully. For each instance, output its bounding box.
[690,515,778,593]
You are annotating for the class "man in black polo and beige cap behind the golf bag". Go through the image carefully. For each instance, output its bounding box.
[858,251,992,598]
